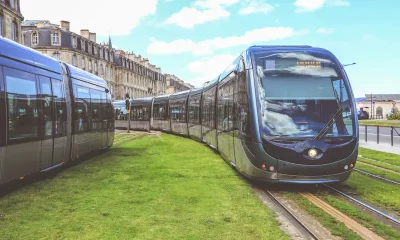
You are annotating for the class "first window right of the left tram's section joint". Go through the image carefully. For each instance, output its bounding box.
[75,85,90,132]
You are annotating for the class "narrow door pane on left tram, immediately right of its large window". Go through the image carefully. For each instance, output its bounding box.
[39,76,54,138]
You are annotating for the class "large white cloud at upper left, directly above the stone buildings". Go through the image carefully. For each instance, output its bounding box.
[21,0,158,36]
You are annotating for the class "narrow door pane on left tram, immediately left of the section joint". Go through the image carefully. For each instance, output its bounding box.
[51,79,67,137]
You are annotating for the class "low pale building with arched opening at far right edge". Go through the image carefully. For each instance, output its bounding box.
[357,94,400,119]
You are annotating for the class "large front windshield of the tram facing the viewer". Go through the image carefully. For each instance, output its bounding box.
[254,52,354,141]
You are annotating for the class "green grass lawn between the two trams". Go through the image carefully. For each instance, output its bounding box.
[0,134,289,239]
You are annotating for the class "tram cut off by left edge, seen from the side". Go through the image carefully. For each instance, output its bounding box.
[0,37,115,184]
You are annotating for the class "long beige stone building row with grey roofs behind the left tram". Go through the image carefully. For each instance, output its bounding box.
[19,19,166,99]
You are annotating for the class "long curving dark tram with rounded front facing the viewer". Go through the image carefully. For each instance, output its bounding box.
[114,46,359,184]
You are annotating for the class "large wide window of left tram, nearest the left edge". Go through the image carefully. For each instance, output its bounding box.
[4,68,39,142]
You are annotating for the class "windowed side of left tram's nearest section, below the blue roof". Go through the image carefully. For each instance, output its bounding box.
[1,58,66,182]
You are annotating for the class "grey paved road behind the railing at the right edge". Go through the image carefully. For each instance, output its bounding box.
[360,126,400,147]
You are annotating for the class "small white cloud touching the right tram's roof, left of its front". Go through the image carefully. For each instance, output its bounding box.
[187,54,239,87]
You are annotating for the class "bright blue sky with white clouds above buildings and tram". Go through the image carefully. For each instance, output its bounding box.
[21,0,400,97]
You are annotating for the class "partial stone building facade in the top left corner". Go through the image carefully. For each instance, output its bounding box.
[0,0,24,43]
